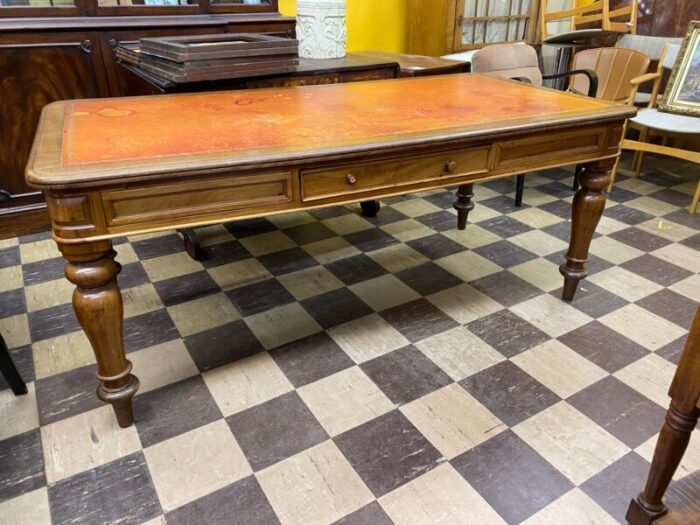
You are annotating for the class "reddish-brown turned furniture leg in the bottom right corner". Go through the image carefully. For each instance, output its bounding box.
[627,302,700,525]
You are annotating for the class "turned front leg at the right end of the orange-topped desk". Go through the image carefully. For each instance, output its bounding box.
[559,159,615,301]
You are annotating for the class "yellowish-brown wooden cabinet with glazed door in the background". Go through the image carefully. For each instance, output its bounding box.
[406,0,539,56]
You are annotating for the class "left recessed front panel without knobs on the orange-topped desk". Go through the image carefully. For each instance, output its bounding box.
[102,172,292,226]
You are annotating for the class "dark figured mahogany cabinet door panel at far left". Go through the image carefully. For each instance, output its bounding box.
[0,34,102,198]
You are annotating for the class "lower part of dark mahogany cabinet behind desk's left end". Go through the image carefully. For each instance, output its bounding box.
[0,12,295,238]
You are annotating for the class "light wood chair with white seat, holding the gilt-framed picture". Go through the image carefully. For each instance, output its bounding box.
[608,43,700,213]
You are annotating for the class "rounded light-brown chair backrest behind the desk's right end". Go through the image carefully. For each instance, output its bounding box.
[569,47,650,102]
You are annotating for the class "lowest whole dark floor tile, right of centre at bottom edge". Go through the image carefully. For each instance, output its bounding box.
[450,430,573,524]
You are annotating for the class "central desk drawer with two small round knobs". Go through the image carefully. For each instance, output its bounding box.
[301,146,490,202]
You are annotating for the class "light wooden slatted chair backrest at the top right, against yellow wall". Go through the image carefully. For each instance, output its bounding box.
[540,0,637,40]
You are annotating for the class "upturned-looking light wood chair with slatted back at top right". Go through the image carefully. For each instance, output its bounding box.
[540,0,637,44]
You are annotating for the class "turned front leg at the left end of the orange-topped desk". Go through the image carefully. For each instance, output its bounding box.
[59,241,139,427]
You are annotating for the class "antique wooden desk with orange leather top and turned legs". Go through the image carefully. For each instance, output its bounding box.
[26,74,635,426]
